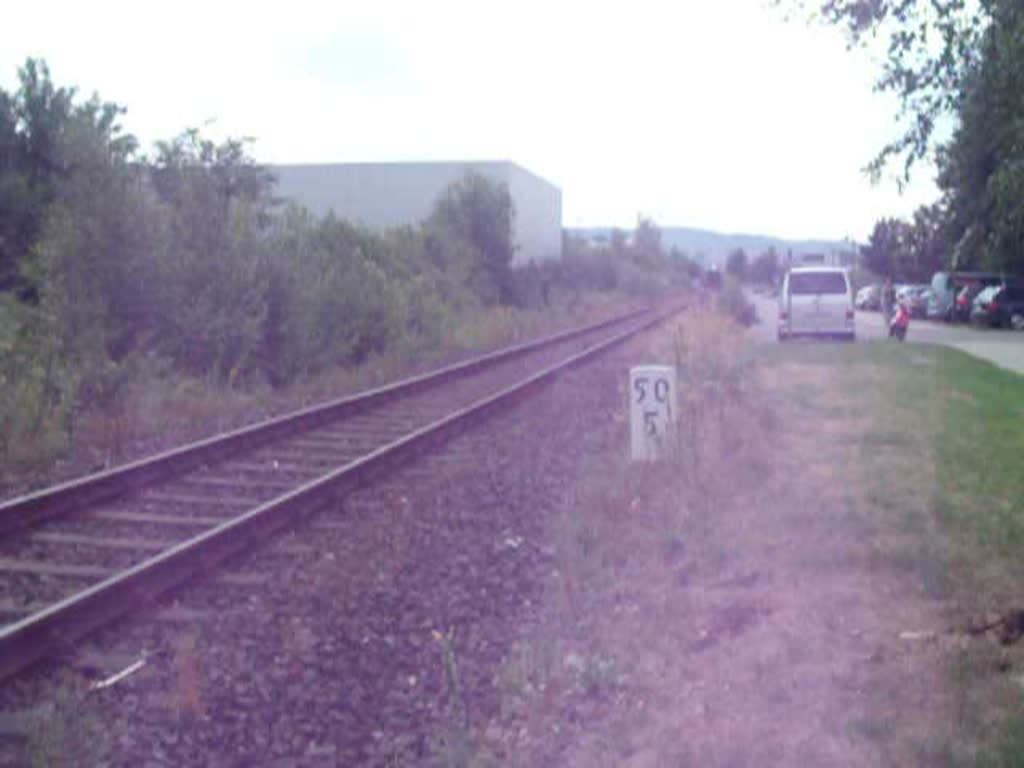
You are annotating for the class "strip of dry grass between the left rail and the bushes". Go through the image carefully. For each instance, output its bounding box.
[0,292,637,498]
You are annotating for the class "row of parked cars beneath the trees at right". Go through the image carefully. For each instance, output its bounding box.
[854,272,1024,330]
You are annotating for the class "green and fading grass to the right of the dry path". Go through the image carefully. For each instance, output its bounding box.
[758,342,1024,768]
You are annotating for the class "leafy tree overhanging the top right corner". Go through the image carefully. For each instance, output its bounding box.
[794,0,1024,280]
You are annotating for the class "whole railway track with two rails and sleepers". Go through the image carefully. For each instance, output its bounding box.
[0,303,666,679]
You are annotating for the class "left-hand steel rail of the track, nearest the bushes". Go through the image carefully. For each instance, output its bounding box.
[0,309,650,536]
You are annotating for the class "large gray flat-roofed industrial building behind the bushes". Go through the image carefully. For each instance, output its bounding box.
[270,161,562,265]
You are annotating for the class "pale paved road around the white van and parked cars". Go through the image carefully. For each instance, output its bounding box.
[751,295,1024,374]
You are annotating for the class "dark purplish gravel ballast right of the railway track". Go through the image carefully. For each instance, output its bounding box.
[0,317,636,766]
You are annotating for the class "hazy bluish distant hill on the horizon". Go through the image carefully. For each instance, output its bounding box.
[568,226,851,266]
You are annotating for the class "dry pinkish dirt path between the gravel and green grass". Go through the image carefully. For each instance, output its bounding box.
[479,319,950,768]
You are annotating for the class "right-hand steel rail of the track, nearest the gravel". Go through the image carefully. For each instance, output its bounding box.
[0,307,682,680]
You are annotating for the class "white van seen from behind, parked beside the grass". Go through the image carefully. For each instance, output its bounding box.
[778,266,855,341]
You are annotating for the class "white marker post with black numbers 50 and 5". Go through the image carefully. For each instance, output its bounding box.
[630,366,677,462]
